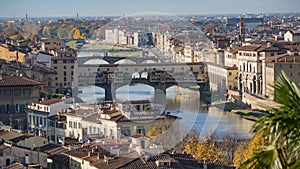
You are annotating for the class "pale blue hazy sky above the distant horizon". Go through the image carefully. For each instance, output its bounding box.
[0,0,300,17]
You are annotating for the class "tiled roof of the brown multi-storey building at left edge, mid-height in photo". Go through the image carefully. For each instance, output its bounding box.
[0,76,43,87]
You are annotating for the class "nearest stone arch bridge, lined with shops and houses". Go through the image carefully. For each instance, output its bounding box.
[78,63,209,100]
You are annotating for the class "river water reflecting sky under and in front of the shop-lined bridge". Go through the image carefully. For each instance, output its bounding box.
[79,84,253,139]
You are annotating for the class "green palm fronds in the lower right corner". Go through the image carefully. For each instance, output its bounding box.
[241,72,300,169]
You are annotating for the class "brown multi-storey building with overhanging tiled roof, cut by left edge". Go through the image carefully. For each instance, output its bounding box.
[0,75,42,130]
